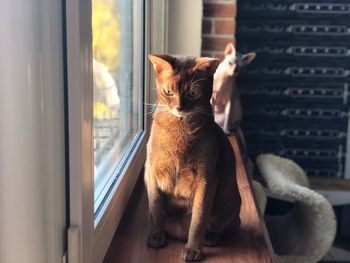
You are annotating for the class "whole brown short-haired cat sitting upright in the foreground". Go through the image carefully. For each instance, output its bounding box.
[145,55,241,262]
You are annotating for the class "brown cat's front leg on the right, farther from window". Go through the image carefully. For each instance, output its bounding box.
[182,177,217,262]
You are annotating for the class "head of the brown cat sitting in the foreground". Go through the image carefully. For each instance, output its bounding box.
[148,55,219,118]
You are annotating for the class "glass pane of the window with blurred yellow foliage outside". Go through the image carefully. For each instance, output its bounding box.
[92,0,143,213]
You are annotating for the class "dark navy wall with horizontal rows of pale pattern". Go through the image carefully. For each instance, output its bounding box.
[236,0,350,177]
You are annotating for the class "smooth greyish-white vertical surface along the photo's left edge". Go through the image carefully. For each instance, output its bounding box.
[0,0,65,263]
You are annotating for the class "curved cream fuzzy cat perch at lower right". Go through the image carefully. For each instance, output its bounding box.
[254,154,336,263]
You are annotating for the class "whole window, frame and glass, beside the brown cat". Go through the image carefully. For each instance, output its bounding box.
[64,0,167,262]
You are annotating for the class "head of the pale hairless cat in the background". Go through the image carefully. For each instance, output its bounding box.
[220,43,256,76]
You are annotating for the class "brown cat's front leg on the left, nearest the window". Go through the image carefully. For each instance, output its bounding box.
[145,167,166,248]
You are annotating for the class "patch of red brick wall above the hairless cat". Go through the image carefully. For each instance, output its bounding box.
[202,0,237,59]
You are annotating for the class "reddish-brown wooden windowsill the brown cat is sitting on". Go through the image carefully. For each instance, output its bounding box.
[104,136,272,263]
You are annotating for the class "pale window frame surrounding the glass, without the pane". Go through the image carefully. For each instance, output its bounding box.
[66,0,167,263]
